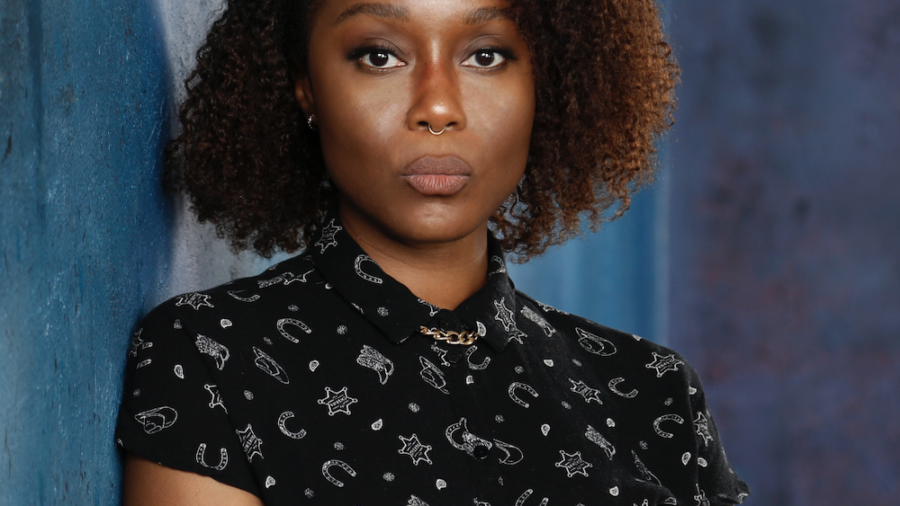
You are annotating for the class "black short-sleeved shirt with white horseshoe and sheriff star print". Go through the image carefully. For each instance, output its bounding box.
[117,214,748,506]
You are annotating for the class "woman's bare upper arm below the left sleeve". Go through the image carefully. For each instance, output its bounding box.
[122,454,263,506]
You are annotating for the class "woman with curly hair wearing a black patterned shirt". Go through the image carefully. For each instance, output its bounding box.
[118,0,747,506]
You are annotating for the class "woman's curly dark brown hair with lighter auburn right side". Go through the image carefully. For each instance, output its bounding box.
[166,0,679,261]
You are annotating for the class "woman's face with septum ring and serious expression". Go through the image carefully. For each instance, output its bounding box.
[297,0,534,245]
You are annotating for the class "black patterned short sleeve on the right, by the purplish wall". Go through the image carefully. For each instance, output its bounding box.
[688,368,750,506]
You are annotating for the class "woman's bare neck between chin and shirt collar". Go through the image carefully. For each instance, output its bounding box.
[341,208,488,309]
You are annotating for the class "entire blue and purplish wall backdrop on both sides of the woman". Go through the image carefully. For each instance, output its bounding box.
[0,0,900,506]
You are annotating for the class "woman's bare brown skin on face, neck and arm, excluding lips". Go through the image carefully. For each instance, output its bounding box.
[123,0,534,506]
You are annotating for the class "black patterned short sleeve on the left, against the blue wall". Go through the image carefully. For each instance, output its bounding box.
[116,304,260,496]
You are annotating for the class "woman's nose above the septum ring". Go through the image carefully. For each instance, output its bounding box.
[407,61,466,132]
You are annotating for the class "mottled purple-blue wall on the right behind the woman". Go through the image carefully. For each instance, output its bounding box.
[670,0,900,506]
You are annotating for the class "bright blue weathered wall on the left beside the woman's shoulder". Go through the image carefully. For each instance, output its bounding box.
[0,0,171,505]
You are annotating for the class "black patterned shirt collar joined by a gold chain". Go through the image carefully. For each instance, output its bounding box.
[310,209,522,352]
